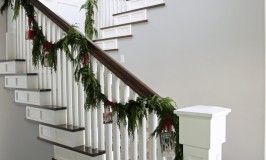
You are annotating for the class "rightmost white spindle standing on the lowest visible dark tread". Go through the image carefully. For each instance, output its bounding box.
[97,62,105,150]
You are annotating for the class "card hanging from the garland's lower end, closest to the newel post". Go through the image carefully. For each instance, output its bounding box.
[160,130,176,157]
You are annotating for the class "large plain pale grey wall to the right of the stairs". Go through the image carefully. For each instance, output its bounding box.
[110,0,265,160]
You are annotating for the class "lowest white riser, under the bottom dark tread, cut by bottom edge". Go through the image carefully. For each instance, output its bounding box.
[54,146,105,160]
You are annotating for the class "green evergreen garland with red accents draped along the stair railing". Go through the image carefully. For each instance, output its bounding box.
[0,0,183,160]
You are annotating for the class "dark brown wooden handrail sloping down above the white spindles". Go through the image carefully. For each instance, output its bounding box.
[29,0,158,97]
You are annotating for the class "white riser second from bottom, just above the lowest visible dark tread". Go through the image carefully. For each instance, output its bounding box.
[39,125,85,147]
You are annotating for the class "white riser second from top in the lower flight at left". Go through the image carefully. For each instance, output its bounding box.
[5,76,38,88]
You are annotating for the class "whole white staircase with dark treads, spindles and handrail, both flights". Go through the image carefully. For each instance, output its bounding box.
[0,0,170,160]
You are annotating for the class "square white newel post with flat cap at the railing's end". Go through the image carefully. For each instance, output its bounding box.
[175,106,231,160]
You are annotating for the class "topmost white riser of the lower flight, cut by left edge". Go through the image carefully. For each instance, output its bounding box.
[0,61,26,74]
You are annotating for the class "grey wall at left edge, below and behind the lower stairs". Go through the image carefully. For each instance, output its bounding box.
[0,8,53,160]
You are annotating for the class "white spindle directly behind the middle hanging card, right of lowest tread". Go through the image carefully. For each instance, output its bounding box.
[104,69,113,160]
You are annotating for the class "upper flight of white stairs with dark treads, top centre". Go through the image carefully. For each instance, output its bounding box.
[94,0,165,51]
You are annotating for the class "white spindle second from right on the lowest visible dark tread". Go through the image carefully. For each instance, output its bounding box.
[91,56,98,148]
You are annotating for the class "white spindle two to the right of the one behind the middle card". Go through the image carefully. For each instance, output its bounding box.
[121,84,129,160]
